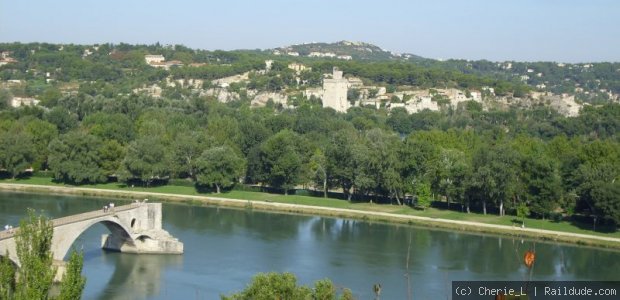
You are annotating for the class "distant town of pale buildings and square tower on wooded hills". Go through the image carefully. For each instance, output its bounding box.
[0,41,620,117]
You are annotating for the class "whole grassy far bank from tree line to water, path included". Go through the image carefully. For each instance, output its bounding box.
[0,177,620,249]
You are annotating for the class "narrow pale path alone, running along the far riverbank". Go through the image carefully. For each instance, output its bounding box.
[0,183,620,248]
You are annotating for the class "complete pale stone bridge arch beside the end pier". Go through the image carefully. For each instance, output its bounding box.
[52,215,134,260]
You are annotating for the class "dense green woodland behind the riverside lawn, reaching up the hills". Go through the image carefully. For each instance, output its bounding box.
[0,44,620,230]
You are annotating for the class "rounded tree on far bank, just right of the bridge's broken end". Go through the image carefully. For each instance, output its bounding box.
[196,146,245,194]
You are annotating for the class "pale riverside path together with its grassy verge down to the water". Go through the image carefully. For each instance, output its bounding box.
[0,183,620,249]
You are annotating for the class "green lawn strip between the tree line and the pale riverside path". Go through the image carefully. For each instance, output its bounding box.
[0,177,620,238]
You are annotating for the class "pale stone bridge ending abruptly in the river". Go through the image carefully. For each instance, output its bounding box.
[0,202,183,266]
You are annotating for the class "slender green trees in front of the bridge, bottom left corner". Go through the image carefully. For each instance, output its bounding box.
[0,209,86,300]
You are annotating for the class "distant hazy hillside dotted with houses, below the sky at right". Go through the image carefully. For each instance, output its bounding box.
[264,41,620,105]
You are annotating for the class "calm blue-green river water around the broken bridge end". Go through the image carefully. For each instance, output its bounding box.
[0,192,620,299]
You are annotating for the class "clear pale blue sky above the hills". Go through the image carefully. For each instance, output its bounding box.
[0,0,620,62]
